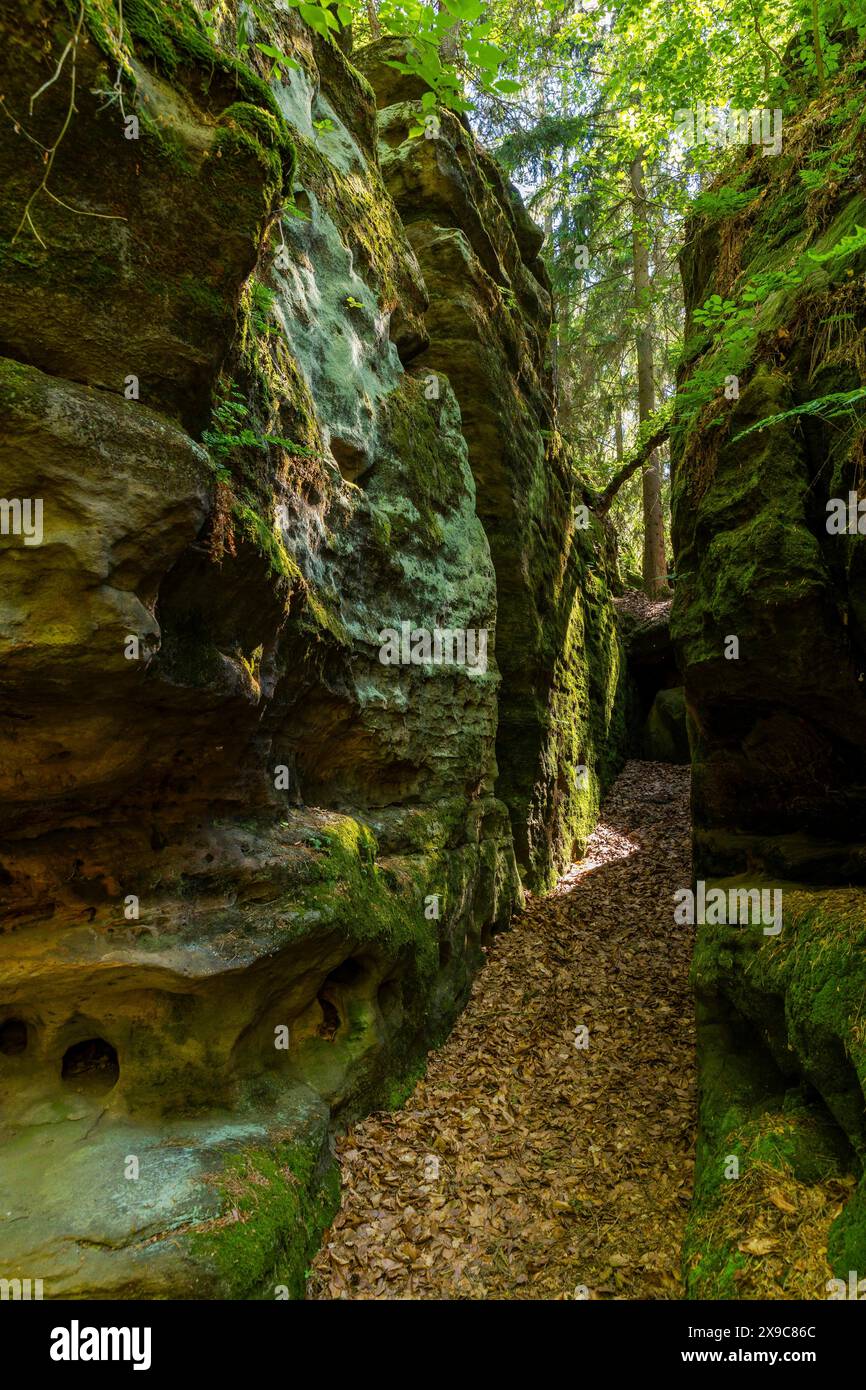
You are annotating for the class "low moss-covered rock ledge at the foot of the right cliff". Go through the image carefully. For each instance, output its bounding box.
[685,880,866,1298]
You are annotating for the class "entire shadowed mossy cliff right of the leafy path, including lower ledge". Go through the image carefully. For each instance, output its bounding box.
[673,46,866,1297]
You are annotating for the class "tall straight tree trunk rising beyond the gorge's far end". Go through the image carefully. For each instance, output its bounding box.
[630,154,669,598]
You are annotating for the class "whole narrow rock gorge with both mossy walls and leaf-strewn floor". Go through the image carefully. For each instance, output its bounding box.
[0,0,866,1301]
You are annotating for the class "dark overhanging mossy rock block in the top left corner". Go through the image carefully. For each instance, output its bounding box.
[0,0,293,432]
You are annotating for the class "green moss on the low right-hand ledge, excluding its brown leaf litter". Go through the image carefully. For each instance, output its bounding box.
[687,880,866,1297]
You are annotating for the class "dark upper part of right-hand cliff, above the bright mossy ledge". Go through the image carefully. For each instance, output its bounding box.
[671,53,866,883]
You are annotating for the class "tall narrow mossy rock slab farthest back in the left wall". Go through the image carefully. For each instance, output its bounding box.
[357,51,628,888]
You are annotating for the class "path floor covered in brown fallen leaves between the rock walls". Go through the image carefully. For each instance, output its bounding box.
[307,762,695,1300]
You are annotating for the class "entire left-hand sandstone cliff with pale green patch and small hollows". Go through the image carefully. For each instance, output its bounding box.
[0,0,620,1297]
